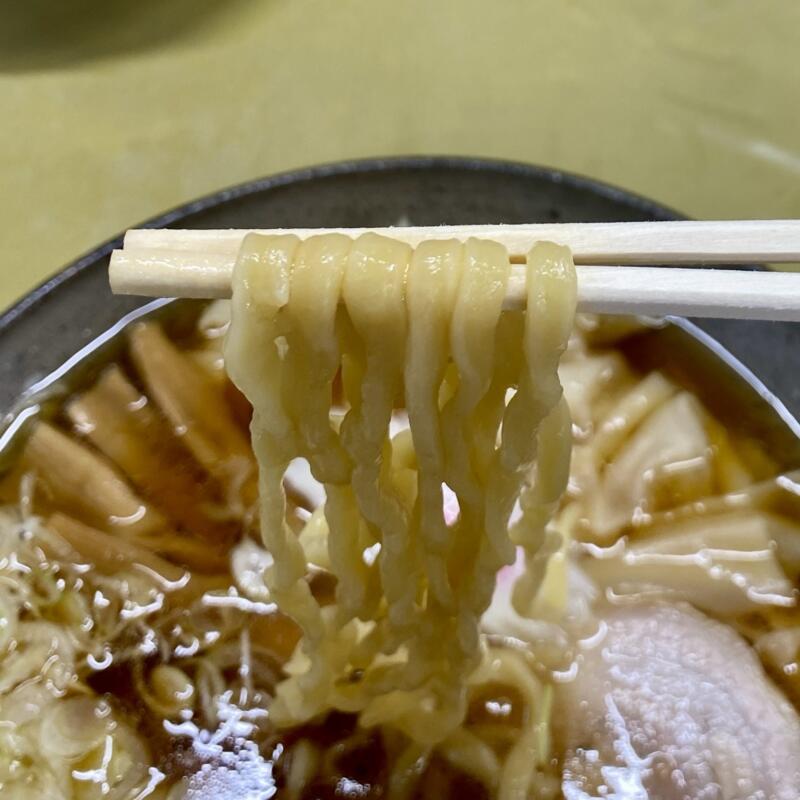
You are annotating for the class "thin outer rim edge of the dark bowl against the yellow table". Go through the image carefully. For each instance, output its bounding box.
[0,155,685,336]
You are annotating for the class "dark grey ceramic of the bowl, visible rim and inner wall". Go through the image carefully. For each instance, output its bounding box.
[0,158,800,466]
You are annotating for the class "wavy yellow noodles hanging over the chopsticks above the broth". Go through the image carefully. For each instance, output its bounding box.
[225,234,575,752]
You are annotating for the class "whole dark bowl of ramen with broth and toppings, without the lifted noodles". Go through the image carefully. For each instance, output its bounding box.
[0,158,800,800]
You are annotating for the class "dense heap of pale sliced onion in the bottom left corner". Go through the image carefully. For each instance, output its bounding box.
[0,502,157,800]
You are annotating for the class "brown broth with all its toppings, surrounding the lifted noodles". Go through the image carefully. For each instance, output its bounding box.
[0,303,800,800]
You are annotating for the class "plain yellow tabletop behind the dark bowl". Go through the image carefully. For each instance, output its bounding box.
[0,0,800,308]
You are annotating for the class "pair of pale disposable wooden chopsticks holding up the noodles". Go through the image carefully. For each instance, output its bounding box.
[109,220,800,320]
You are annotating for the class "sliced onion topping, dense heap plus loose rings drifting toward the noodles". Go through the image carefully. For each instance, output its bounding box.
[0,490,279,800]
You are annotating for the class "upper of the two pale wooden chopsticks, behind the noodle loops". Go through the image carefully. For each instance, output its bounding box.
[125,220,800,264]
